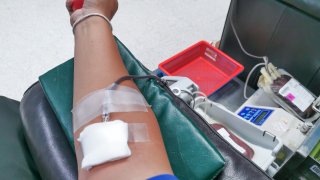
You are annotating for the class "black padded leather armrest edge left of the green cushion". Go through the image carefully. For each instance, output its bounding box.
[20,83,78,180]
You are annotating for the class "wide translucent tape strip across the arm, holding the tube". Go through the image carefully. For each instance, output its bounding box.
[72,84,150,132]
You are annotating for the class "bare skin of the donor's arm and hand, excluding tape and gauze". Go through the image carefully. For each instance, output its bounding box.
[66,0,173,180]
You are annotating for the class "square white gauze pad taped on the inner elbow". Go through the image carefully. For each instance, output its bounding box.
[78,120,131,170]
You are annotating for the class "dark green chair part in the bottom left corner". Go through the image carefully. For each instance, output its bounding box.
[0,96,40,180]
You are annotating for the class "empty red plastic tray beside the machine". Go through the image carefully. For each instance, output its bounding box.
[159,41,244,96]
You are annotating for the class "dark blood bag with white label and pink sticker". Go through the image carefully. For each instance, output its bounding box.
[258,66,320,122]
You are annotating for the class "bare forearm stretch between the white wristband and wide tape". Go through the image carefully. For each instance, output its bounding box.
[74,16,133,103]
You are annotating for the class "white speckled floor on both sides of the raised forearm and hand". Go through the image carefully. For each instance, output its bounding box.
[0,0,230,100]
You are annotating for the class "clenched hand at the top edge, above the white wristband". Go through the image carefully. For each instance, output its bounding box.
[66,0,118,25]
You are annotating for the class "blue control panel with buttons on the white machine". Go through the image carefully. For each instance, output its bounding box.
[238,106,273,126]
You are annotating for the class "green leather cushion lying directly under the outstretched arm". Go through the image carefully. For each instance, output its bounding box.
[39,39,224,180]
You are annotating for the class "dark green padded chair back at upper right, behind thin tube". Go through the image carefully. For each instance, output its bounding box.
[220,0,320,95]
